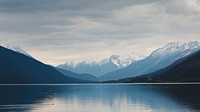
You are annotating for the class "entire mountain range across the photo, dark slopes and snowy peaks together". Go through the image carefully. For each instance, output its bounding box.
[0,41,200,84]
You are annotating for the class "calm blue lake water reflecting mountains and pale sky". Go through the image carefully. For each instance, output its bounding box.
[0,84,200,112]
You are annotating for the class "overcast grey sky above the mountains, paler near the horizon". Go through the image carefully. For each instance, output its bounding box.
[0,0,200,65]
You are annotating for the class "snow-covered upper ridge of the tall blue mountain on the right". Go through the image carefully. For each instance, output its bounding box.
[151,41,200,57]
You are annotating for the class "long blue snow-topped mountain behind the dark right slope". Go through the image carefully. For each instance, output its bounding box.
[100,41,200,81]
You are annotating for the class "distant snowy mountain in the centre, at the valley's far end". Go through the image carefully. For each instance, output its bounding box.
[57,53,144,77]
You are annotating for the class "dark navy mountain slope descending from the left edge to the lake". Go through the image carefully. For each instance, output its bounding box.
[0,46,83,84]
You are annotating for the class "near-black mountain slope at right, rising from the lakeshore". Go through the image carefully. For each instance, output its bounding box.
[118,48,200,83]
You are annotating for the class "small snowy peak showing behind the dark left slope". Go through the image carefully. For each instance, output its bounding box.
[1,44,33,58]
